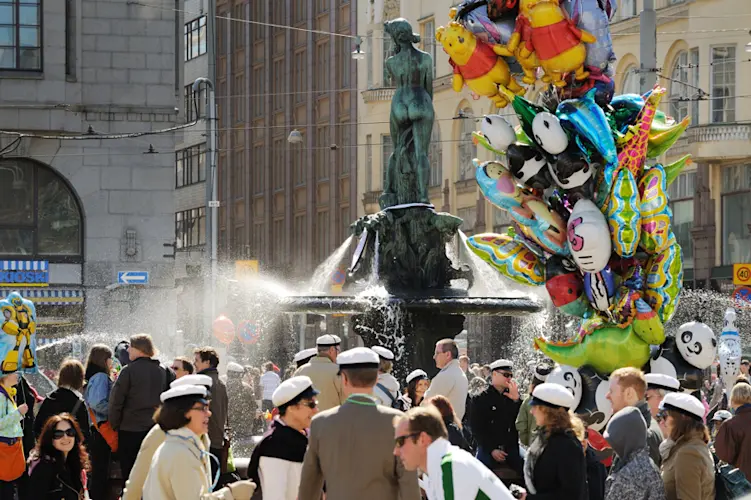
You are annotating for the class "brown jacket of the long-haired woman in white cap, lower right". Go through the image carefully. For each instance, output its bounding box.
[660,434,715,500]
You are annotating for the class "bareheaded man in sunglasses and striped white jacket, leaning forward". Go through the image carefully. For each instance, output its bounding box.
[394,406,514,500]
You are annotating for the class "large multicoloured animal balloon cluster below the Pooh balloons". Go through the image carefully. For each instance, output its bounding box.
[468,87,689,374]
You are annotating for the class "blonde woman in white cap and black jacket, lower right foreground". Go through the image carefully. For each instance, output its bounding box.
[524,383,587,500]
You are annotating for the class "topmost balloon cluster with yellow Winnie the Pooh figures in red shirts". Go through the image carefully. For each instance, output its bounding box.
[436,0,615,107]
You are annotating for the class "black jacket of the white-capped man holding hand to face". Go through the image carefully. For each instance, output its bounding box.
[470,385,522,456]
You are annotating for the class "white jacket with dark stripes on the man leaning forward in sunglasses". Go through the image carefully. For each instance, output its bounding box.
[425,438,514,500]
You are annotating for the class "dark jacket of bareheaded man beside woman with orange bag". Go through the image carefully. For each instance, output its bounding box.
[109,358,174,432]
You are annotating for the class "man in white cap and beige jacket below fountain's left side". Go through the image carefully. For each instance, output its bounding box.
[295,334,344,411]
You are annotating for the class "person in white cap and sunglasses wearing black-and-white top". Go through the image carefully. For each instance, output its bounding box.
[248,375,318,500]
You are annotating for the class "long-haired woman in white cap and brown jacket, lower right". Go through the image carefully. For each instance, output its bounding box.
[657,392,715,500]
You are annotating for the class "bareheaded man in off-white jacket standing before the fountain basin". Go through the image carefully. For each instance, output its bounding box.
[422,339,469,421]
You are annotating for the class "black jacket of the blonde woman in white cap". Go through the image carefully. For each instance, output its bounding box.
[527,430,587,500]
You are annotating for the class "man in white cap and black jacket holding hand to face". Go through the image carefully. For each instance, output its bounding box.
[470,359,524,476]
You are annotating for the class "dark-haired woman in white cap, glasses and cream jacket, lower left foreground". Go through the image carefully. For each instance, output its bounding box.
[140,382,255,500]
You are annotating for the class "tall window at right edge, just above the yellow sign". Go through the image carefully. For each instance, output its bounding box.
[722,165,751,266]
